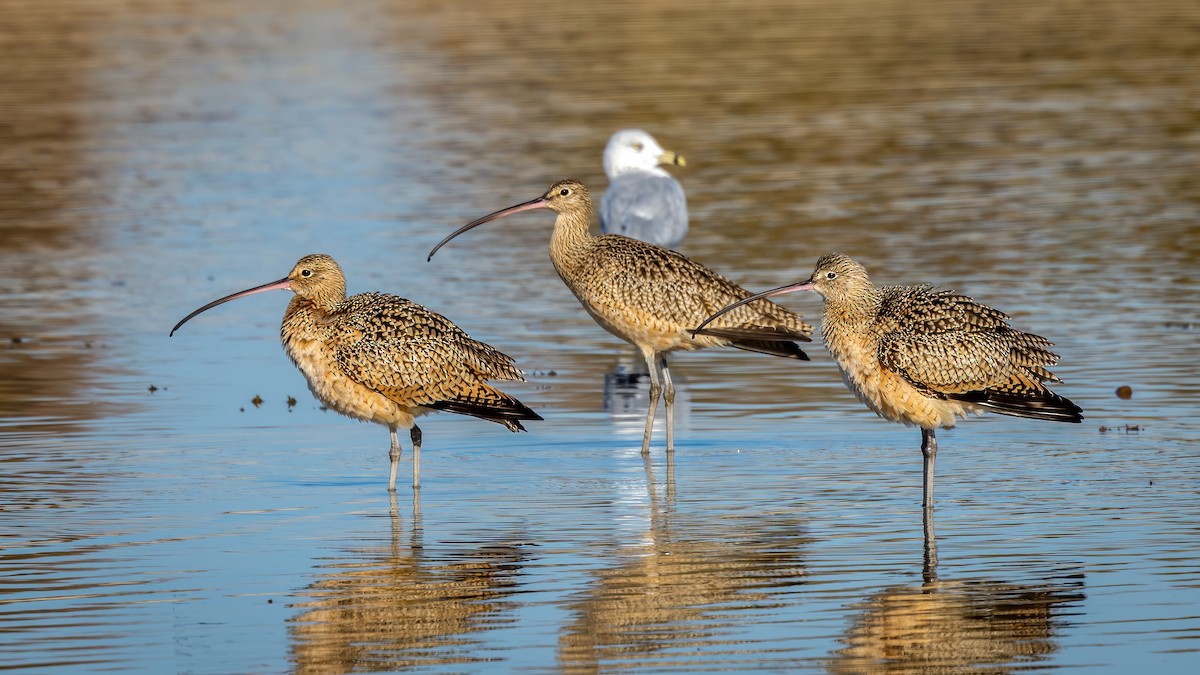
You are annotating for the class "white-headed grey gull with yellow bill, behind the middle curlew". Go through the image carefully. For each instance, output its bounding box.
[600,129,688,249]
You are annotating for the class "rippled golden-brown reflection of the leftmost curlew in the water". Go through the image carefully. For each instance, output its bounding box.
[289,495,526,674]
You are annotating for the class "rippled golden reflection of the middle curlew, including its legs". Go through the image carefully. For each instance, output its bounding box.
[559,456,808,673]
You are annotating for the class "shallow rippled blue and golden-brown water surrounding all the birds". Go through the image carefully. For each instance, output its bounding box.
[0,0,1200,673]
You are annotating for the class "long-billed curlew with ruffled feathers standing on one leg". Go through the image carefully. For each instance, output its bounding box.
[697,253,1084,507]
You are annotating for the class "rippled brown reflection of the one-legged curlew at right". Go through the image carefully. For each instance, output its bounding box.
[828,509,1086,675]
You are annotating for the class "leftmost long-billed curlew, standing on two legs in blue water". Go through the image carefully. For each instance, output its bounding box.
[170,255,541,491]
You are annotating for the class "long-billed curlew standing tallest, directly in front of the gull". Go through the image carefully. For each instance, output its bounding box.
[430,180,812,454]
